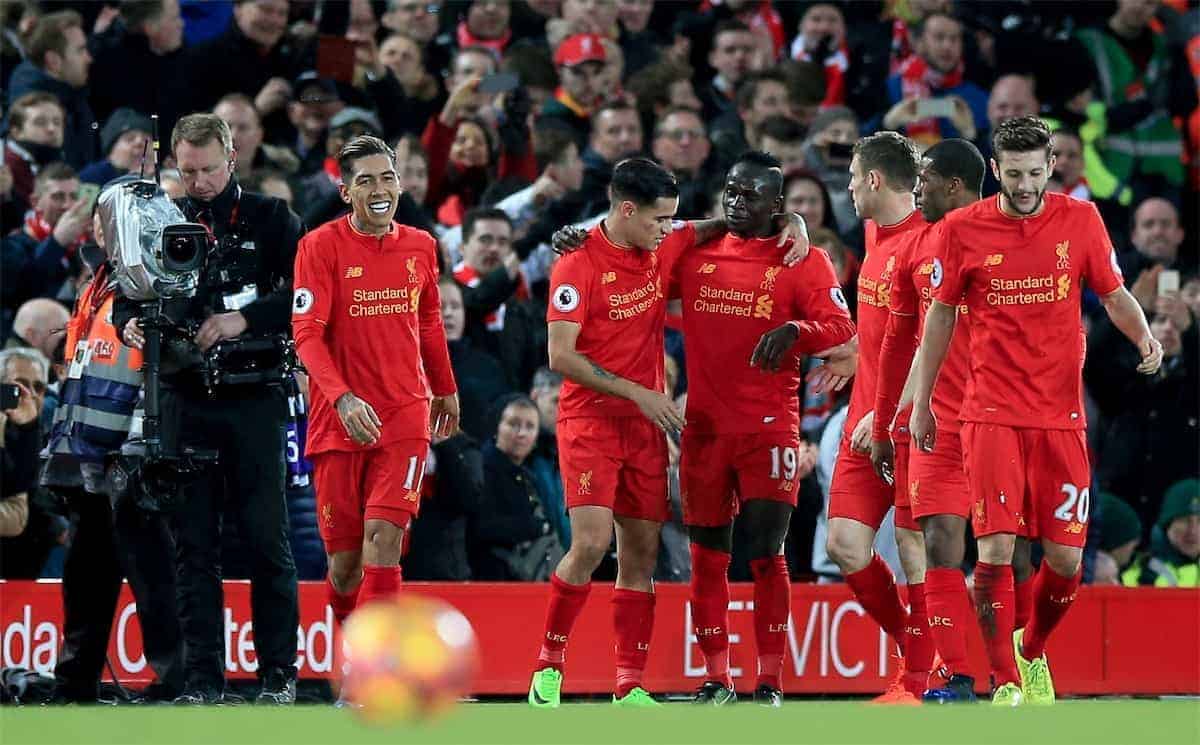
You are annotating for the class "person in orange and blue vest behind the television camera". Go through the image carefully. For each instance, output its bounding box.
[41,205,184,703]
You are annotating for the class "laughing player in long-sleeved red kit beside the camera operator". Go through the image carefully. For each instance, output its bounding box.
[292,136,458,620]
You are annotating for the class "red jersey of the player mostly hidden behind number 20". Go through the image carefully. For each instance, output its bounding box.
[876,218,971,432]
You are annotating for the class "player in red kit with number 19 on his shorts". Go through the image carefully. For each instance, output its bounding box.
[671,152,854,707]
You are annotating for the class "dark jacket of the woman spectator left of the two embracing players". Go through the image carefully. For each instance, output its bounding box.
[468,441,553,582]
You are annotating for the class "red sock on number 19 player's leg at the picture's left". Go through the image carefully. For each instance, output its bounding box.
[691,543,733,689]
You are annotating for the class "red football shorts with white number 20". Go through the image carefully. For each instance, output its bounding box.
[962,422,1091,548]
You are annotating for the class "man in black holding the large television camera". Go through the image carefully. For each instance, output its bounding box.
[114,114,301,704]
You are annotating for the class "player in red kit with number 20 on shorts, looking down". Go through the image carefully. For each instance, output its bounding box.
[910,116,1163,705]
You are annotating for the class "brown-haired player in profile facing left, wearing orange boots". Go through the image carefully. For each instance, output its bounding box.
[826,132,934,704]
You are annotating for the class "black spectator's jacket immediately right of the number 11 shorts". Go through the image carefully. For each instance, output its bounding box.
[403,434,484,582]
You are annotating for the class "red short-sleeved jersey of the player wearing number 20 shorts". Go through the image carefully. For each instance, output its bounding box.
[934,192,1123,429]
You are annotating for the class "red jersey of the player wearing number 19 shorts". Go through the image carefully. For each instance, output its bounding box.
[671,233,854,434]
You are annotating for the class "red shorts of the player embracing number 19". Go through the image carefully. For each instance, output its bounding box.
[558,416,671,523]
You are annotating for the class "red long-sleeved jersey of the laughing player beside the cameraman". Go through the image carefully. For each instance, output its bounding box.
[292,216,456,455]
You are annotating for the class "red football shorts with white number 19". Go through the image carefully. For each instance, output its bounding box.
[679,429,800,528]
